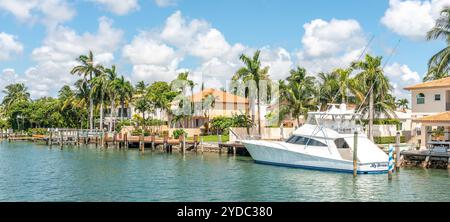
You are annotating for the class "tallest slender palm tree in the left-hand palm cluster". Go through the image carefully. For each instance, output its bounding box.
[70,51,101,130]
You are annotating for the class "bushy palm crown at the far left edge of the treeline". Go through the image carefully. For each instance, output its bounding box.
[1,83,30,112]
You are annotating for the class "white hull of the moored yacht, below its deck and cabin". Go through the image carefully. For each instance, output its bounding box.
[243,142,388,174]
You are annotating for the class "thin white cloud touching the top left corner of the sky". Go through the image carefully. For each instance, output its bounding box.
[0,0,75,28]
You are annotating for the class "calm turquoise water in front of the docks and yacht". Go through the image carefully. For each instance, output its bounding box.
[0,142,450,201]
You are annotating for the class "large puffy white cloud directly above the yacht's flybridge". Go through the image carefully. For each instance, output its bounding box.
[297,19,367,74]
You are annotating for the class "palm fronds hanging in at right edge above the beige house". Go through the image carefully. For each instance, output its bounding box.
[427,6,450,79]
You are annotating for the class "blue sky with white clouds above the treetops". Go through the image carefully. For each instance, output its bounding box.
[0,0,450,98]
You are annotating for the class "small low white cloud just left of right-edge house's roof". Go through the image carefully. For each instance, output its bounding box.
[384,63,420,99]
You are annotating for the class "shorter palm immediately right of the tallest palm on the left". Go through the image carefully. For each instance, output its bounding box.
[91,68,109,130]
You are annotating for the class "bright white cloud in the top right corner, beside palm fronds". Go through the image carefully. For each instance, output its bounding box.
[381,0,450,40]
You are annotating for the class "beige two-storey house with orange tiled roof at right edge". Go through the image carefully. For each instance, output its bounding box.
[405,77,450,149]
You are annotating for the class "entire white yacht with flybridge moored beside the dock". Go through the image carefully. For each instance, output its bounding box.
[242,104,388,174]
